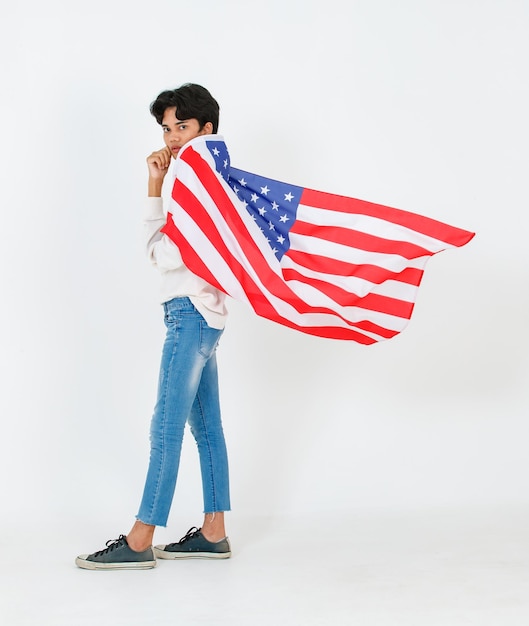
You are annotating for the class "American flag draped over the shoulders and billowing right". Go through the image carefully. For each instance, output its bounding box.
[162,135,474,344]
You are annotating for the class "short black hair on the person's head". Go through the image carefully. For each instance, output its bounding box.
[150,83,219,133]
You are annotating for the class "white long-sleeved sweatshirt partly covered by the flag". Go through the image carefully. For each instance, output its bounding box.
[144,197,228,329]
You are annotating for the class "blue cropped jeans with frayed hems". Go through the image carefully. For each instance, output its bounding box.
[137,297,230,526]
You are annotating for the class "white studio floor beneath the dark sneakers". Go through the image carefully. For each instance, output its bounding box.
[0,509,529,626]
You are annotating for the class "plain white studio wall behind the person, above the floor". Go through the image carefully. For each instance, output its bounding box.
[0,0,529,620]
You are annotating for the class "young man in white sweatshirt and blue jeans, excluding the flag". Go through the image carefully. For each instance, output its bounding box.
[76,84,231,569]
